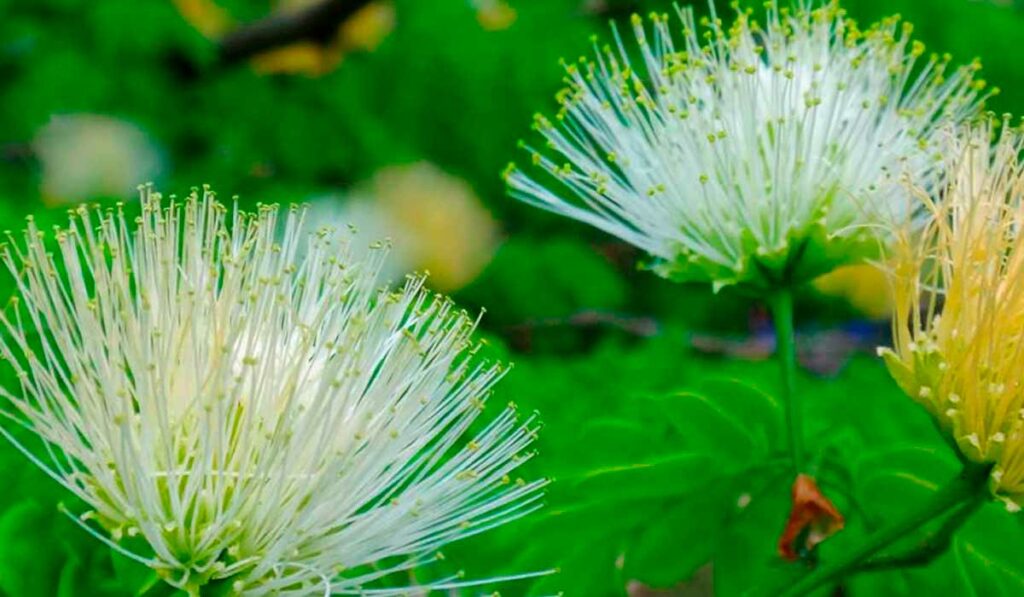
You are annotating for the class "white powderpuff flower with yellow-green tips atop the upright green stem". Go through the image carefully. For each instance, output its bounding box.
[506,1,985,289]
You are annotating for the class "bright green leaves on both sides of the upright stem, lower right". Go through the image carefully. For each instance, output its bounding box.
[447,333,1024,596]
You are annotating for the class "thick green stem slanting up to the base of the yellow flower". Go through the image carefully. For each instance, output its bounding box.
[779,464,992,597]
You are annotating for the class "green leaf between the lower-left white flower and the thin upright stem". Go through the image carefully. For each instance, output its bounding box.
[454,334,785,595]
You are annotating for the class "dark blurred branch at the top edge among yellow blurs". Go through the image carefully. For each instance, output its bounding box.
[219,0,369,63]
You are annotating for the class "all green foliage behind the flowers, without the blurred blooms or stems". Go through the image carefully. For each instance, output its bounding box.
[0,0,1024,597]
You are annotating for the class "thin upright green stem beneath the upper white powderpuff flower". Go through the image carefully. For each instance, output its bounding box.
[769,288,804,474]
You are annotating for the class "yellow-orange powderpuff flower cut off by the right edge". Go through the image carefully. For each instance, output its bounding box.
[880,124,1024,510]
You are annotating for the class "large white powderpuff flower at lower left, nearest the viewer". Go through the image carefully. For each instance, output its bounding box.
[0,189,545,595]
